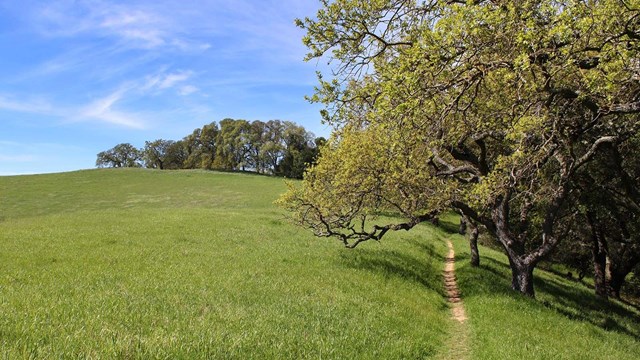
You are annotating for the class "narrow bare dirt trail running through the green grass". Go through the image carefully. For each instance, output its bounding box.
[442,239,470,360]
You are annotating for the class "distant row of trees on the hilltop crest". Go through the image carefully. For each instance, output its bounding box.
[96,119,326,178]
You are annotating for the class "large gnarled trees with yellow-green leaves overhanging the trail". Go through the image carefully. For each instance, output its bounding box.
[280,0,640,297]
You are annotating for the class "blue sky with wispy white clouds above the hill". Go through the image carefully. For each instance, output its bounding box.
[0,0,329,175]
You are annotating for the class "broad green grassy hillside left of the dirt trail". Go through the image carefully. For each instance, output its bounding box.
[0,169,452,359]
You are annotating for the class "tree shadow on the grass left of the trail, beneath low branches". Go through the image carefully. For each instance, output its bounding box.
[340,241,445,296]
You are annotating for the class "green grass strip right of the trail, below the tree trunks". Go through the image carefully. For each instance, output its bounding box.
[454,224,640,360]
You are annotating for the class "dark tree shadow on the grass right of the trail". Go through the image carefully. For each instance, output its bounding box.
[459,257,640,340]
